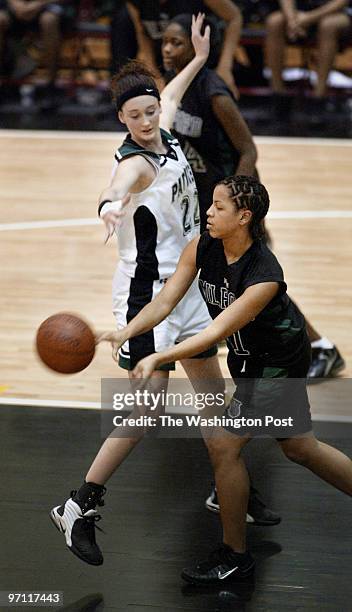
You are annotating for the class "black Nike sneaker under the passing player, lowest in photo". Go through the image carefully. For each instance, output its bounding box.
[181,544,255,585]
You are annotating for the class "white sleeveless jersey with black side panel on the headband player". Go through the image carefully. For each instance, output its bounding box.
[115,130,200,280]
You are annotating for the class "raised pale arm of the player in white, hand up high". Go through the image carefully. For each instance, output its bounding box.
[160,14,210,130]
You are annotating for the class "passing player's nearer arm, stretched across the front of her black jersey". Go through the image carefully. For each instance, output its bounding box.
[132,282,278,379]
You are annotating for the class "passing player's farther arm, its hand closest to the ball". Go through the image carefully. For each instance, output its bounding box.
[97,238,199,353]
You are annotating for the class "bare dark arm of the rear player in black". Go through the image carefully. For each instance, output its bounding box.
[211,95,257,176]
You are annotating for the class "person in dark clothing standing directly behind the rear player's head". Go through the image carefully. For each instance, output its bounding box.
[111,0,242,96]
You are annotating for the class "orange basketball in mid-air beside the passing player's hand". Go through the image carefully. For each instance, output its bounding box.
[36,312,95,374]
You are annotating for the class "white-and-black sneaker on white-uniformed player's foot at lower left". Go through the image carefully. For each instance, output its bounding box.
[50,490,105,565]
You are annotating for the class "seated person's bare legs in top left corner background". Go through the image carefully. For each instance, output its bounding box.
[0,0,73,107]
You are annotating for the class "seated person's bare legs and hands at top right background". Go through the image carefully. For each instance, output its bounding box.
[266,0,350,109]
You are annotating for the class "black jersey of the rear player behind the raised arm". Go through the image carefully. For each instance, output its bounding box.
[172,67,240,227]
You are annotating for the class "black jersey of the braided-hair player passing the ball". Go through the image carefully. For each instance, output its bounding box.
[197,232,305,366]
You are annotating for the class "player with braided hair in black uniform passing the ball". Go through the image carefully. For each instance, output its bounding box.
[105,176,352,584]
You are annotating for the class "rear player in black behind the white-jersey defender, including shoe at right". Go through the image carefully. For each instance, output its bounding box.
[162,14,345,383]
